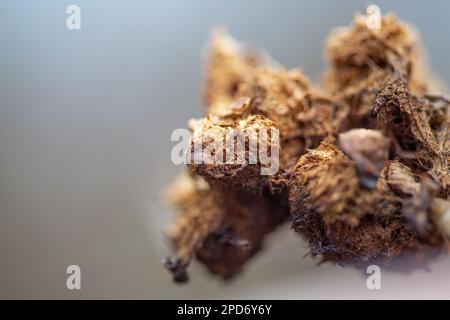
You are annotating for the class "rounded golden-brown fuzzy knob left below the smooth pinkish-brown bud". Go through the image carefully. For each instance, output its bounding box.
[289,141,375,225]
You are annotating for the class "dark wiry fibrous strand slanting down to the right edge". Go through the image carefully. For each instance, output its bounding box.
[374,77,450,193]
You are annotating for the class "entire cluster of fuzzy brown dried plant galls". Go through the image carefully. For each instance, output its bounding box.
[164,6,450,282]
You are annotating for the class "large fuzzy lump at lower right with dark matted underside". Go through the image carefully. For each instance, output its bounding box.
[289,142,446,265]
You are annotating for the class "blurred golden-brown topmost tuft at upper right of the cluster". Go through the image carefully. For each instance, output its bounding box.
[326,15,424,91]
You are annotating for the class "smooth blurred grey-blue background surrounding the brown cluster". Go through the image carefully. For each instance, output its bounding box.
[0,0,450,299]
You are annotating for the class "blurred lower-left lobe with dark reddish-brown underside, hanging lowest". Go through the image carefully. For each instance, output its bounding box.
[164,175,288,282]
